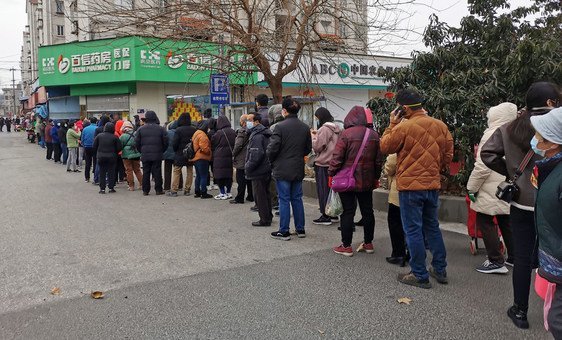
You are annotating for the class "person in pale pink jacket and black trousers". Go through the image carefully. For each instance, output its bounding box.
[311,107,341,225]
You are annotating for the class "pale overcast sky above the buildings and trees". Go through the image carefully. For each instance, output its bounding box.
[0,0,530,87]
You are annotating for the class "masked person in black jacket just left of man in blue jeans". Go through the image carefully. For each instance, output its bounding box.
[244,114,273,227]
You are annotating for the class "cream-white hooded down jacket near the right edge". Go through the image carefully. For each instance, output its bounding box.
[466,103,517,216]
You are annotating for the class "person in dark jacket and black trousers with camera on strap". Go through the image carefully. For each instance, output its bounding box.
[480,82,560,329]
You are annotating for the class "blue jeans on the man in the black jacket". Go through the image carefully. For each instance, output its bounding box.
[276,179,304,233]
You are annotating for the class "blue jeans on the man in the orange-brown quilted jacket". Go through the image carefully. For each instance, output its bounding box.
[399,190,447,280]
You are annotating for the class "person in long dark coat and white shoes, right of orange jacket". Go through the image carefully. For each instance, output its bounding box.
[211,116,236,200]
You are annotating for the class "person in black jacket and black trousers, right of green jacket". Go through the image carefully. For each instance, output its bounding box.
[135,111,168,196]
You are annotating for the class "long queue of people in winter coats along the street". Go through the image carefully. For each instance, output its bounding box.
[30,82,562,338]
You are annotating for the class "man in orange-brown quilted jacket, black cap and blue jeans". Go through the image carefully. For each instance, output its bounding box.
[381,89,453,288]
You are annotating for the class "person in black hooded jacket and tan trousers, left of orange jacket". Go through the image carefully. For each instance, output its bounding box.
[170,113,197,196]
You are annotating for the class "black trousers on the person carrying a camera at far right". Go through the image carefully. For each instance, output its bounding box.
[510,206,538,311]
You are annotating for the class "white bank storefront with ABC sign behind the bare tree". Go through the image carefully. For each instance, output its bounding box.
[258,55,412,126]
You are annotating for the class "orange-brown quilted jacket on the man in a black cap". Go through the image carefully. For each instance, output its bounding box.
[381,112,453,191]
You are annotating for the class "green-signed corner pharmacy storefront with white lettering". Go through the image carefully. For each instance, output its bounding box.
[39,36,256,122]
